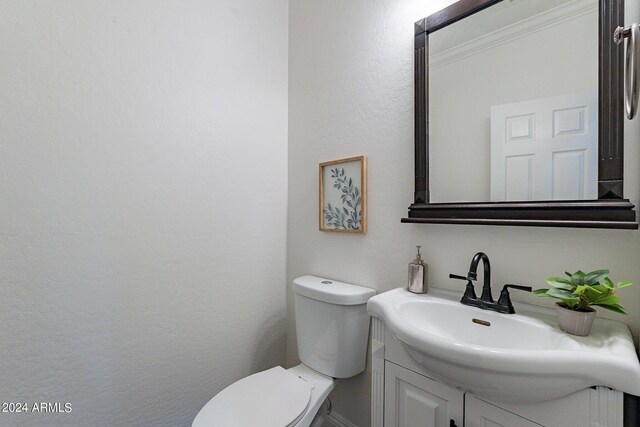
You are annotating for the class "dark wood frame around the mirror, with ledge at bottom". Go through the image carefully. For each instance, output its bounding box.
[402,0,638,229]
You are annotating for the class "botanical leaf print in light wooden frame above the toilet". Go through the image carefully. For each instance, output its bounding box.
[320,156,367,233]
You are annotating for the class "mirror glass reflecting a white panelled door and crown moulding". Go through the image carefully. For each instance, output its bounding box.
[428,0,598,203]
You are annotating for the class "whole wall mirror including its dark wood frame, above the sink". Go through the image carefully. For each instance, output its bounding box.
[403,0,638,228]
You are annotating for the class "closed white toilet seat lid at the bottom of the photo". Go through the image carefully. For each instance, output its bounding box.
[193,366,312,427]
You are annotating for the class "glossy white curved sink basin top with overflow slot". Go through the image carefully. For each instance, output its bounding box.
[367,289,640,402]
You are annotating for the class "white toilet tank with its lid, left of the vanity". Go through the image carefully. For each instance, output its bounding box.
[293,276,376,378]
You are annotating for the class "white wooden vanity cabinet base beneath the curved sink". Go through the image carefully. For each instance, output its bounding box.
[371,317,626,427]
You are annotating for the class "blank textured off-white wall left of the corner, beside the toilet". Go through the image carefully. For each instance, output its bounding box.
[0,0,288,426]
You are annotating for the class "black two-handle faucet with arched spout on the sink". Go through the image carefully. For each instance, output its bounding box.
[449,252,531,314]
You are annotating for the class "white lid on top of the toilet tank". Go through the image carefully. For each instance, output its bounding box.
[293,276,376,305]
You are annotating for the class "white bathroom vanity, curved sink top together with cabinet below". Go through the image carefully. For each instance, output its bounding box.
[369,289,640,427]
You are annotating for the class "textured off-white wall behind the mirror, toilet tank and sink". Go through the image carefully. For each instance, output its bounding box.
[287,0,640,427]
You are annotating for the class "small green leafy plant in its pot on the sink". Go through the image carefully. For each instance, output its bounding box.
[533,270,633,336]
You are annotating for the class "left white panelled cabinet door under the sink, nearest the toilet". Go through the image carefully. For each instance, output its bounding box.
[384,362,464,427]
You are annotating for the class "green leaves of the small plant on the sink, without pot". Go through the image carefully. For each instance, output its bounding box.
[533,270,633,314]
